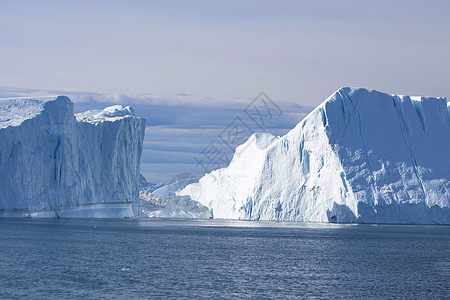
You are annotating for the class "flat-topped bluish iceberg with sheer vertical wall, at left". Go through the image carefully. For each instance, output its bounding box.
[0,96,145,218]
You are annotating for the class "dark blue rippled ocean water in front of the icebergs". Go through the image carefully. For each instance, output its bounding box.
[0,219,450,299]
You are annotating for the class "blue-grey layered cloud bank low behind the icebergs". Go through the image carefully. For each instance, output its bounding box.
[0,87,312,182]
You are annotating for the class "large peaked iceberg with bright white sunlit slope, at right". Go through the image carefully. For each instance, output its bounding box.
[179,88,450,224]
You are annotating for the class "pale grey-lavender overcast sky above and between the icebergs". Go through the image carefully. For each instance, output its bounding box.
[0,0,450,181]
